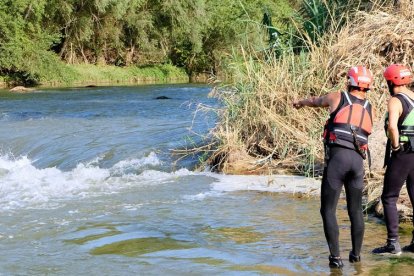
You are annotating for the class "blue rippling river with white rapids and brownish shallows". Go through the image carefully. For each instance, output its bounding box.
[0,85,414,275]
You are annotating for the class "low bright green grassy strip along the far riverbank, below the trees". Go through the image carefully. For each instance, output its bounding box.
[0,64,190,88]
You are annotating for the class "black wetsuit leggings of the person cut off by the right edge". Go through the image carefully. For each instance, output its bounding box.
[381,149,414,239]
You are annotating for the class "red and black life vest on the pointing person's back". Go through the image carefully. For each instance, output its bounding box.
[323,91,372,151]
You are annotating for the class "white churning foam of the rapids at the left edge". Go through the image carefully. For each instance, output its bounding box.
[0,152,191,210]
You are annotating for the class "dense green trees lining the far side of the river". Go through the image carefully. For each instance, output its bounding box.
[0,0,296,84]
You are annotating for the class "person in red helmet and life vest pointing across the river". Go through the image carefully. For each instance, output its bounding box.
[293,66,373,268]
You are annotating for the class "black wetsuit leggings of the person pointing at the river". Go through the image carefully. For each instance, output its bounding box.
[321,147,364,256]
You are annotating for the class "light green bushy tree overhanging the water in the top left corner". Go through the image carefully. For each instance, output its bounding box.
[0,0,71,84]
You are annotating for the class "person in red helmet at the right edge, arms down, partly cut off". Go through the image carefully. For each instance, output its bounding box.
[373,64,414,255]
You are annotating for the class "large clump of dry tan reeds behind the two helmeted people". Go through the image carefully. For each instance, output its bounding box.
[207,1,414,181]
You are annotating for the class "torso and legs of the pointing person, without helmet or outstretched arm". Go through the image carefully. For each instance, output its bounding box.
[320,89,372,266]
